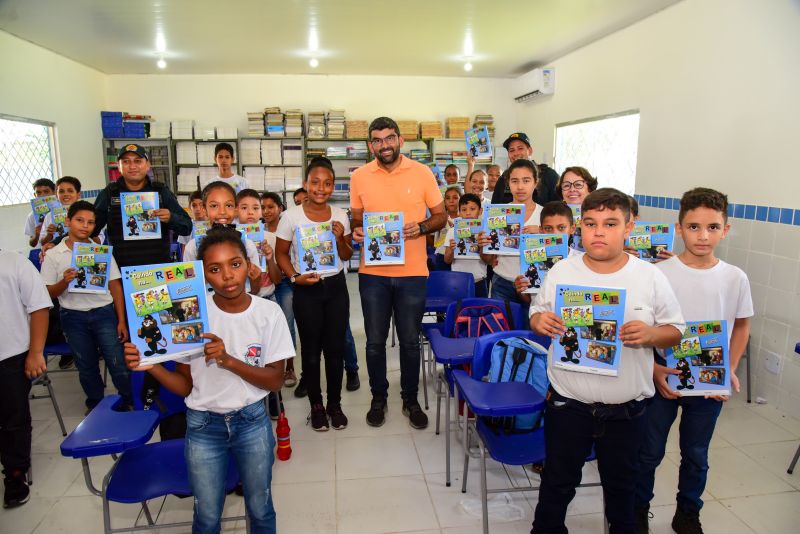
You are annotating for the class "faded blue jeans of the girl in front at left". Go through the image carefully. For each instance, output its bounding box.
[185,400,277,534]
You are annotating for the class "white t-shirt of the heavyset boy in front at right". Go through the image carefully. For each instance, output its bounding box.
[530,254,686,404]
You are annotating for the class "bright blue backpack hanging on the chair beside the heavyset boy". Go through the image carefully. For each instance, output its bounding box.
[484,337,549,433]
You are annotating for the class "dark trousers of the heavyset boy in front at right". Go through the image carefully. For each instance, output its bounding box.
[531,388,645,534]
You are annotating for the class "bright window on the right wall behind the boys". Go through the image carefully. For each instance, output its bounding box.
[555,110,639,195]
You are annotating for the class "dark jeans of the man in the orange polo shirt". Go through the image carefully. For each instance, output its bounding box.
[358,274,428,401]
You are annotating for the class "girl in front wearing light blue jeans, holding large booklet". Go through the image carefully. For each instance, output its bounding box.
[125,225,294,534]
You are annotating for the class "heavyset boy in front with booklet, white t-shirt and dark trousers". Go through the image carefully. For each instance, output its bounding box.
[528,188,685,533]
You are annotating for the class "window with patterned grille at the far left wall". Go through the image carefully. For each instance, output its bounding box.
[0,115,59,206]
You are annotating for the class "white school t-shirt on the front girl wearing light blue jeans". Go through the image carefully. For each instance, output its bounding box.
[183,297,295,413]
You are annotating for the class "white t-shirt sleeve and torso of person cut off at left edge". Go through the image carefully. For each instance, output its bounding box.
[0,250,53,361]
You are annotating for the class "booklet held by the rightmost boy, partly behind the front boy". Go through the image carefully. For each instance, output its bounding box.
[665,321,731,397]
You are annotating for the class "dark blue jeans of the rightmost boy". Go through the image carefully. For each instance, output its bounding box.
[636,391,722,512]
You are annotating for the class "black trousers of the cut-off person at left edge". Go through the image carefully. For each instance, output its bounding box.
[0,352,31,476]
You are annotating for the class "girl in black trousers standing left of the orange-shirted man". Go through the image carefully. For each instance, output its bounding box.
[276,157,353,432]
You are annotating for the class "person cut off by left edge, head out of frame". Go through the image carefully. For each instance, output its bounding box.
[0,250,53,510]
